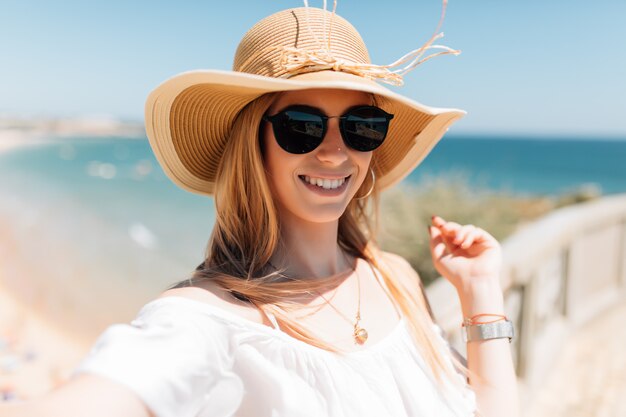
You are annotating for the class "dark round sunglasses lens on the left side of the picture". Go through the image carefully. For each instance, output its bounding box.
[274,110,325,153]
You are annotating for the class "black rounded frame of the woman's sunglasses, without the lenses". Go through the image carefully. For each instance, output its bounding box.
[262,104,394,154]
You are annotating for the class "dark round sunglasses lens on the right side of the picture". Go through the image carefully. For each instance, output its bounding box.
[342,107,393,152]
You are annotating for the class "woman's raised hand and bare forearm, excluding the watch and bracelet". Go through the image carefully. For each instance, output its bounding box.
[429,216,520,417]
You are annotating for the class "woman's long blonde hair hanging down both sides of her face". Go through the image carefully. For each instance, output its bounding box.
[166,93,478,406]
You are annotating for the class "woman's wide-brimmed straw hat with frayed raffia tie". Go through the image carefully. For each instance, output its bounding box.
[145,3,465,195]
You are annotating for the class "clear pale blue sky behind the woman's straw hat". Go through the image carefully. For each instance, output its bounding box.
[0,0,626,138]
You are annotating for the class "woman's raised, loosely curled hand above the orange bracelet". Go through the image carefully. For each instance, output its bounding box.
[428,216,502,293]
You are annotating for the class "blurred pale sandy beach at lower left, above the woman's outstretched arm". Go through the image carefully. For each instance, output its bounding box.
[0,206,149,402]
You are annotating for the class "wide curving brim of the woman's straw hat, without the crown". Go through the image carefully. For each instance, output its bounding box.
[145,70,466,195]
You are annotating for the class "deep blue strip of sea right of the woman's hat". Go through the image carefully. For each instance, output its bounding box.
[408,136,626,195]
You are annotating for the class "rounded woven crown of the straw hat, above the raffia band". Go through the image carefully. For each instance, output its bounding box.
[233,7,371,78]
